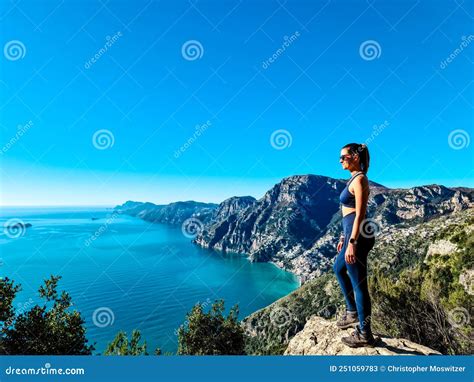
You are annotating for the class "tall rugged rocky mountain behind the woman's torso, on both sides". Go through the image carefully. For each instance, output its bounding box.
[194,175,474,281]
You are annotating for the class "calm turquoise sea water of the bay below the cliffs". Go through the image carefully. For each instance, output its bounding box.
[0,207,299,353]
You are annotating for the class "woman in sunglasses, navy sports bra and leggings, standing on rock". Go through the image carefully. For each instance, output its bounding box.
[334,143,375,347]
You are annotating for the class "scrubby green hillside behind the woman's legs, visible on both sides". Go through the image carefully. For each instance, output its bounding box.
[243,210,474,355]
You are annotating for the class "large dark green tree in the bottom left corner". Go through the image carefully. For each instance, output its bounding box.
[0,276,94,355]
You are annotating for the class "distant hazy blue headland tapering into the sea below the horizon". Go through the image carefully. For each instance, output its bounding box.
[114,200,219,225]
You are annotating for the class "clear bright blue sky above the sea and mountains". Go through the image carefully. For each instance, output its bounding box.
[0,0,474,205]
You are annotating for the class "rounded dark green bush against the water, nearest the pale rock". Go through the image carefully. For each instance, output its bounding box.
[178,300,245,355]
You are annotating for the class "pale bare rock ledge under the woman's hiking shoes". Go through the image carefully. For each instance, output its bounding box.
[284,316,441,355]
